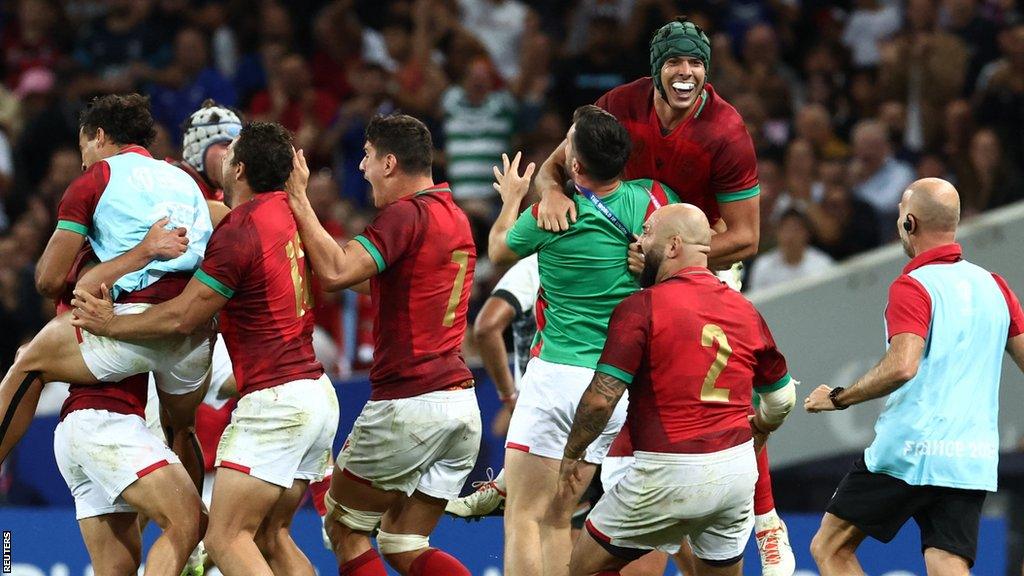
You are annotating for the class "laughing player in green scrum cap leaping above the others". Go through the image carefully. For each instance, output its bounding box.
[537,16,796,576]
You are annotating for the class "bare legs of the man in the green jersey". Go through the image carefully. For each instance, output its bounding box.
[505,449,597,576]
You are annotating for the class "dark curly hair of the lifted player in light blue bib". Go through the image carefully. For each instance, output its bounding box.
[78,94,157,148]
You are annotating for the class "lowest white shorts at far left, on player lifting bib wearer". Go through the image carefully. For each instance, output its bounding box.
[53,410,180,520]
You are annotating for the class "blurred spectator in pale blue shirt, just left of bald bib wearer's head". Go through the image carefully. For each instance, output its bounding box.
[851,120,914,221]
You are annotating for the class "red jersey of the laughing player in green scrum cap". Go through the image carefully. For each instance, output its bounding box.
[596,77,761,224]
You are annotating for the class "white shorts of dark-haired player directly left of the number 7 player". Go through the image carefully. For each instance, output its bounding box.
[216,375,339,489]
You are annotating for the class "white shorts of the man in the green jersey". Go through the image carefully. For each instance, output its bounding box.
[505,357,629,464]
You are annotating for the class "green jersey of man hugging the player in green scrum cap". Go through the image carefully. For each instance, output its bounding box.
[506,179,679,368]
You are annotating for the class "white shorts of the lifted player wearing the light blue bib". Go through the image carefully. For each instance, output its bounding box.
[76,303,213,395]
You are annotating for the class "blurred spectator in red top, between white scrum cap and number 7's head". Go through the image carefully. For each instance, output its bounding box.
[249,53,337,153]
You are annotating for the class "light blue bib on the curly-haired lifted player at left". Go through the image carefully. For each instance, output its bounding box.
[89,153,213,298]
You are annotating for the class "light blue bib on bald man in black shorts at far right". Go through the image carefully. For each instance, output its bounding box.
[864,260,1010,492]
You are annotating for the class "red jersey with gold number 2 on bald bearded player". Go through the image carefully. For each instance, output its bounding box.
[597,268,790,454]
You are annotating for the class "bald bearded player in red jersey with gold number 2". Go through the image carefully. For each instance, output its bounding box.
[559,205,796,576]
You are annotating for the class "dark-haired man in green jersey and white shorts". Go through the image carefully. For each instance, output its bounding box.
[488,106,678,575]
